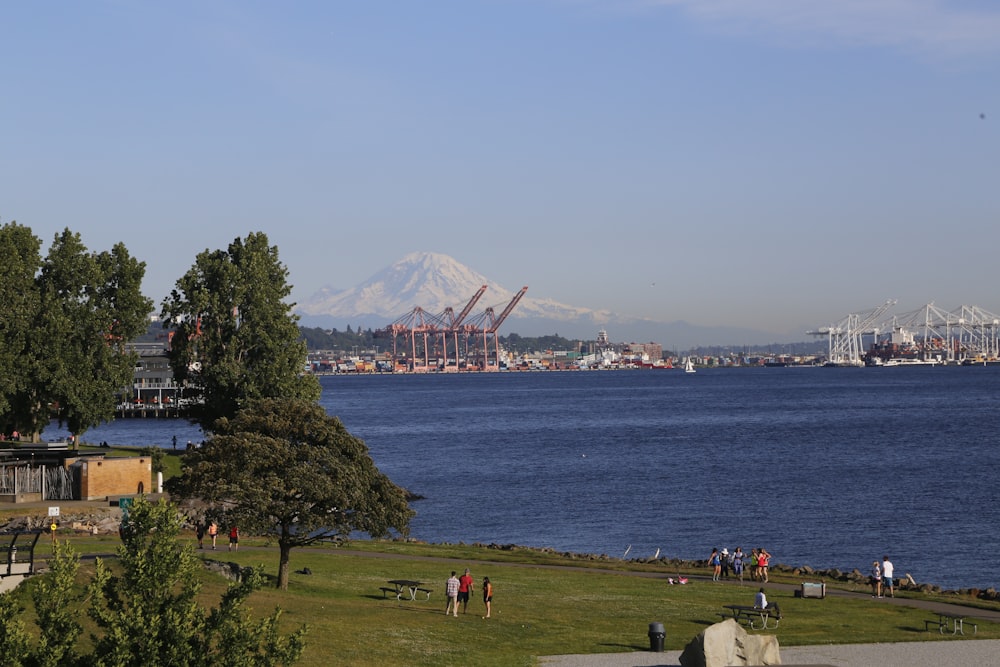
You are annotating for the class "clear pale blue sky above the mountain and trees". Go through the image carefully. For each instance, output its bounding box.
[0,0,1000,333]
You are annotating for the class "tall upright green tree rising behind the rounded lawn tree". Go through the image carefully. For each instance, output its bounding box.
[162,232,320,430]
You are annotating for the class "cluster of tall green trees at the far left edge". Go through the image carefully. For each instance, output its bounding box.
[0,223,153,436]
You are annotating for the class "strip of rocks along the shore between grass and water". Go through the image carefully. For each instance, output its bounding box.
[0,506,1000,601]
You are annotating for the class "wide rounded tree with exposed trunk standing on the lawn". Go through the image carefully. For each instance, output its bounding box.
[170,399,413,589]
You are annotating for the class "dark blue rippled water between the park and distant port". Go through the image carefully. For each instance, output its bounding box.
[45,367,1000,588]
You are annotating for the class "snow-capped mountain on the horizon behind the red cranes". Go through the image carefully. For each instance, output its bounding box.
[296,252,796,345]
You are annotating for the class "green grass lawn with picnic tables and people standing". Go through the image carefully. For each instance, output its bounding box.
[19,537,1000,667]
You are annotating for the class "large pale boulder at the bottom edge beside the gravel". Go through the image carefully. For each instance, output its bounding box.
[681,618,781,667]
